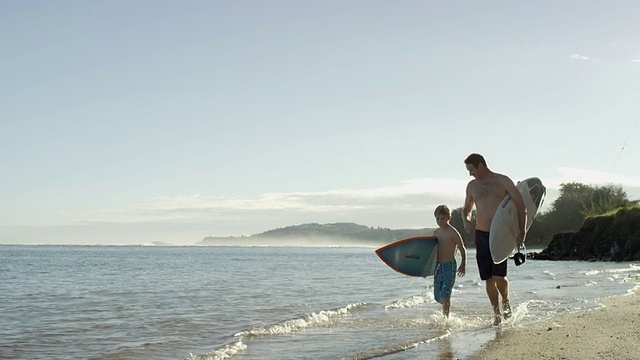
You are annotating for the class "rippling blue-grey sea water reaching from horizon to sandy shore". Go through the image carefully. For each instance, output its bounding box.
[0,246,640,360]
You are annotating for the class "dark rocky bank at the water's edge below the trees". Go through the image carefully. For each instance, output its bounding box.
[528,207,640,261]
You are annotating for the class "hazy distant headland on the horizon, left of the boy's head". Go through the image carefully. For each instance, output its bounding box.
[196,223,434,247]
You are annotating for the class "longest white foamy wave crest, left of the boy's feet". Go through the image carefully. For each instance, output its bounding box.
[235,303,366,337]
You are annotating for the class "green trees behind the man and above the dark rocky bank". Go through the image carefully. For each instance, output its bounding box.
[451,182,640,246]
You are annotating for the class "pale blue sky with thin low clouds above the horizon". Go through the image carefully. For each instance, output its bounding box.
[0,0,640,245]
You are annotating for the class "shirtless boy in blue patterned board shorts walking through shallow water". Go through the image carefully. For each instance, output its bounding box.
[433,205,467,317]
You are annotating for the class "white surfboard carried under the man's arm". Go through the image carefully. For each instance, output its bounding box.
[489,178,547,264]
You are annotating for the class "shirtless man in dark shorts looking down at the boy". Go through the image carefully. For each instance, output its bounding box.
[462,154,526,326]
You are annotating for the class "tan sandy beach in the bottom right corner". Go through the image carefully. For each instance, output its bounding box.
[469,293,640,360]
